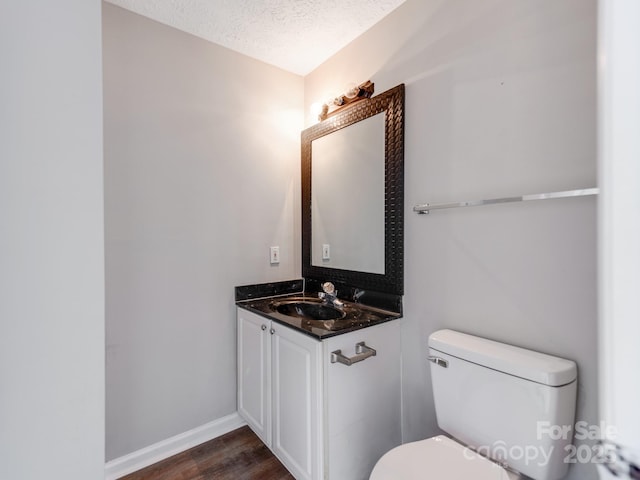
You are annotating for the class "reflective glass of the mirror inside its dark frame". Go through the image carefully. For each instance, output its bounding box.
[311,113,384,274]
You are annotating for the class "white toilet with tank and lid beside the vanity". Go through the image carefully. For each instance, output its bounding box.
[369,330,577,480]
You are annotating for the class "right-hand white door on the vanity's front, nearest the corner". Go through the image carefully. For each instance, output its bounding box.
[271,323,323,480]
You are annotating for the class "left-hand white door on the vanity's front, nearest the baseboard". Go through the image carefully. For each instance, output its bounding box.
[237,308,271,447]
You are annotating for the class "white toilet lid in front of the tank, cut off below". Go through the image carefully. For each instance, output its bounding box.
[369,435,517,480]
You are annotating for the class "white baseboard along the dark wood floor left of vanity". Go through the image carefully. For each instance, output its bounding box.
[104,412,246,480]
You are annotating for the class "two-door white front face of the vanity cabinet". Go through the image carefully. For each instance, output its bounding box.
[238,308,322,480]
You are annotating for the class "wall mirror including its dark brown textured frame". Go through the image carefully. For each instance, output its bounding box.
[302,85,404,294]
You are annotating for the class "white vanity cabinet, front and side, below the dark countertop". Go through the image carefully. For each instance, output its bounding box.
[238,308,401,480]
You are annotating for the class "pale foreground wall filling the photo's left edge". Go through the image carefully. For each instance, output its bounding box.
[0,0,104,480]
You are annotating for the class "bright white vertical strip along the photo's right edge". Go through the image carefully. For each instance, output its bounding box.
[598,0,640,464]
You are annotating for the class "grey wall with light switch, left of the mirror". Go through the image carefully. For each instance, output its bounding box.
[103,4,303,460]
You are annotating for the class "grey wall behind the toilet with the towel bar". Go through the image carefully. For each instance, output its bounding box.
[305,0,597,480]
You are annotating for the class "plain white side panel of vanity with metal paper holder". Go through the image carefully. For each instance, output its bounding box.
[323,320,402,480]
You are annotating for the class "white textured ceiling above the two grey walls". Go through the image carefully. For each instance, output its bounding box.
[107,0,405,75]
